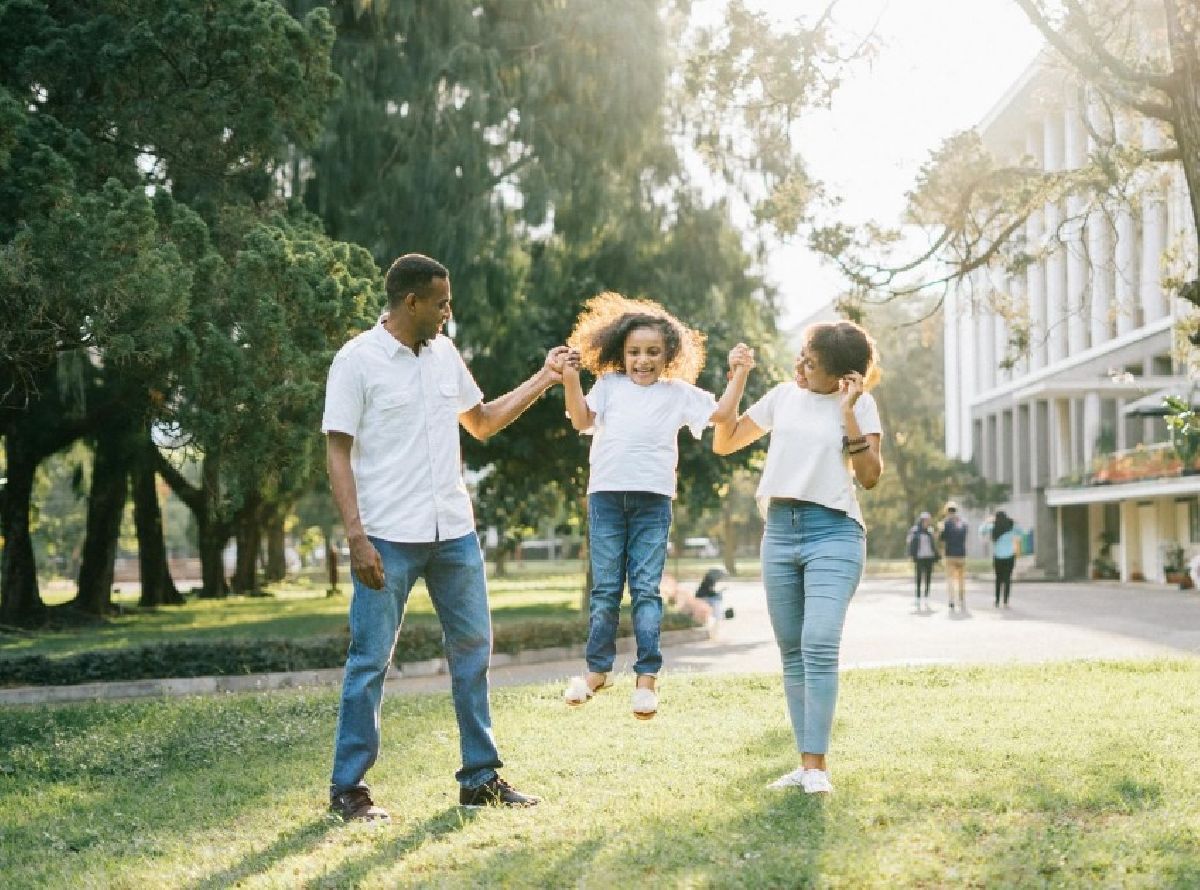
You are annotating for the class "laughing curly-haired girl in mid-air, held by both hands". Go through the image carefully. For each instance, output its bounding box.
[563,293,754,720]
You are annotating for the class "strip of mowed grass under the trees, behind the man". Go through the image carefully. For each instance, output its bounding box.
[0,575,583,657]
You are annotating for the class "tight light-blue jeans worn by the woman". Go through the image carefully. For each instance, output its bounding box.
[762,500,866,754]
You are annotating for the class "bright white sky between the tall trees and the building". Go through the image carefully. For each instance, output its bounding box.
[724,0,1042,326]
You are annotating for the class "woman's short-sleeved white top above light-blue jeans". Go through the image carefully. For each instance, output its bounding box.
[746,383,883,527]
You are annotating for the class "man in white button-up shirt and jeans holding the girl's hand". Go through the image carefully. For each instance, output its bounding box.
[322,253,566,820]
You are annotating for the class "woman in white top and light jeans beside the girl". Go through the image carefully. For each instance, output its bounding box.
[713,321,883,794]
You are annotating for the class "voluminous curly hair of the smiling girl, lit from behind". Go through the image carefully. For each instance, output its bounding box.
[566,290,704,384]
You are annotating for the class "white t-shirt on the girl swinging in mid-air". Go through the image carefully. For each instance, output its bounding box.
[584,372,716,498]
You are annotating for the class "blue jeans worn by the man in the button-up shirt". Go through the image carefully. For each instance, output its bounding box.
[331,534,503,794]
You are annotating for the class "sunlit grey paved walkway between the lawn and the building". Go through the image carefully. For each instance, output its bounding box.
[398,578,1200,691]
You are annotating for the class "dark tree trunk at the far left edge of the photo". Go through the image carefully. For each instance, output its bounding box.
[0,423,46,627]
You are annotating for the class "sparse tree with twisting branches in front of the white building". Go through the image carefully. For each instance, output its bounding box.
[810,0,1200,340]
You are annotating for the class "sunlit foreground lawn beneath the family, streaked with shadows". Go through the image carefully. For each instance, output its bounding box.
[0,661,1200,890]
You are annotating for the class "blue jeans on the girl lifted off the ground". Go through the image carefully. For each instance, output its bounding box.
[586,492,671,674]
